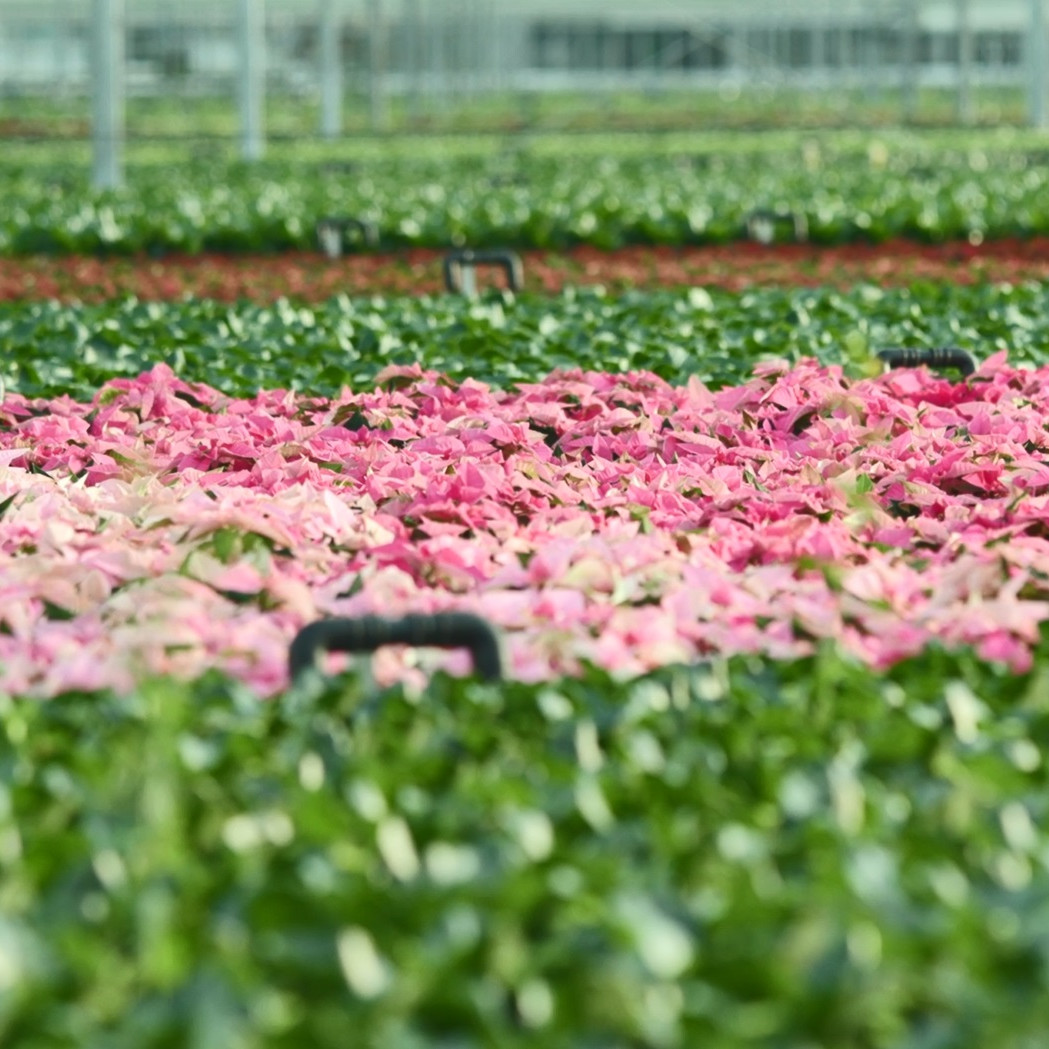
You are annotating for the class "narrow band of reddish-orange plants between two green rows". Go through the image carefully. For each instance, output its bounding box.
[6,237,1049,303]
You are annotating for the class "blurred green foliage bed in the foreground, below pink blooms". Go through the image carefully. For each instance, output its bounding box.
[6,651,1049,1049]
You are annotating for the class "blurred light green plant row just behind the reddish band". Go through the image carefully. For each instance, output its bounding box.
[6,140,1049,255]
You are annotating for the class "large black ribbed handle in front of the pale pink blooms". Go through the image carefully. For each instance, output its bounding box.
[288,612,502,681]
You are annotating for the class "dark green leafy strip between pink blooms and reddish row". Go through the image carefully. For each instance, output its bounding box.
[0,282,1049,398]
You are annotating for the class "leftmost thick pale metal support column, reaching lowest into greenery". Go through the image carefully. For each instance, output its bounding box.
[91,0,124,189]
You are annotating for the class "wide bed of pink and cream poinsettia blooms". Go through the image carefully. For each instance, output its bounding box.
[0,355,1049,697]
